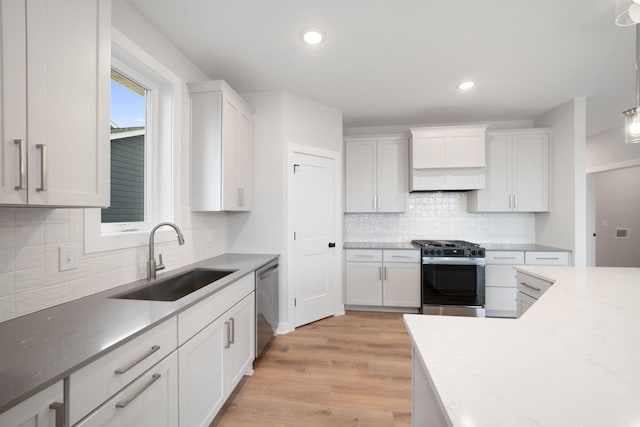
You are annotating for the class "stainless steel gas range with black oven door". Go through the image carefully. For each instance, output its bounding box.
[411,240,486,317]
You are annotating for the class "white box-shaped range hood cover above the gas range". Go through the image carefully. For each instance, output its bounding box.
[409,125,487,191]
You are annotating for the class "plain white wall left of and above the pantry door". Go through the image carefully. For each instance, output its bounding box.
[227,91,342,333]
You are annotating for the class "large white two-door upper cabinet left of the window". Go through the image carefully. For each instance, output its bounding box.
[0,0,111,206]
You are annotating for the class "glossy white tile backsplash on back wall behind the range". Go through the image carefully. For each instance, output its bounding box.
[344,192,535,243]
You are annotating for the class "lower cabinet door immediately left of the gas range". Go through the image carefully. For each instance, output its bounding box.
[382,263,421,307]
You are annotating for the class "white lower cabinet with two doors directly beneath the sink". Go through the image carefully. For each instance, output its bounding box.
[178,274,255,427]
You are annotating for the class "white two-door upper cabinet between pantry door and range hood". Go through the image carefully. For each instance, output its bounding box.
[345,136,409,212]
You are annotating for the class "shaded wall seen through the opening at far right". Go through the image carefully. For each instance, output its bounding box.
[594,166,640,267]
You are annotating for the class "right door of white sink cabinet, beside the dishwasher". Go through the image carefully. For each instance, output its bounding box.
[224,293,255,395]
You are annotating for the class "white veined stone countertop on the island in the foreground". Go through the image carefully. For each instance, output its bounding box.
[404,266,640,427]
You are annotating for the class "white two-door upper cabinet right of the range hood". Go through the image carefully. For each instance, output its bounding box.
[468,129,549,212]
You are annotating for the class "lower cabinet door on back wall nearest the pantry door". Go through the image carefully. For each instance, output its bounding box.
[345,262,382,305]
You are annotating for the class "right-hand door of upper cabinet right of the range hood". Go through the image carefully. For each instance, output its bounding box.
[512,134,549,212]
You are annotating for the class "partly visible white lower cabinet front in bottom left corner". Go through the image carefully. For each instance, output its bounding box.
[0,381,64,427]
